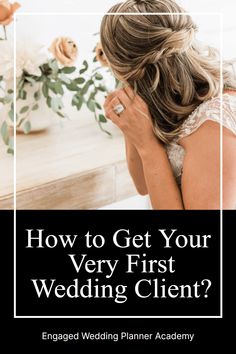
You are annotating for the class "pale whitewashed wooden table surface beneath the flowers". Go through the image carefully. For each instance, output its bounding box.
[0,112,134,208]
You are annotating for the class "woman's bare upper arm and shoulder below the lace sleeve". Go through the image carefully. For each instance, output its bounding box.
[180,120,236,209]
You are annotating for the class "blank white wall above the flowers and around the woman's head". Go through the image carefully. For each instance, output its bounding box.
[17,0,236,60]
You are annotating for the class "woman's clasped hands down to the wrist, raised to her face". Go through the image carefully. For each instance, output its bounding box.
[104,87,159,151]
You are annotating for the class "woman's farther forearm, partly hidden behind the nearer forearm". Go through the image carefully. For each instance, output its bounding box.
[125,136,148,195]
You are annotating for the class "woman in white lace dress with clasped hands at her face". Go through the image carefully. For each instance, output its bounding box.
[101,0,236,209]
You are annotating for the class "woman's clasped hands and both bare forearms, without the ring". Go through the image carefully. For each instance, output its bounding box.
[104,87,183,209]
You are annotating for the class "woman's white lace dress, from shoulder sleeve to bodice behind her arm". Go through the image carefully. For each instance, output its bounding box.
[166,93,236,186]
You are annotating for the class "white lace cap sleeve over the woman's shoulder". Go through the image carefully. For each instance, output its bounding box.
[178,94,236,140]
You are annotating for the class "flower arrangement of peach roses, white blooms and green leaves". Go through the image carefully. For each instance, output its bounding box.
[0,0,119,153]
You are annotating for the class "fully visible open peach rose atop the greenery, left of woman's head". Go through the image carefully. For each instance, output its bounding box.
[49,37,78,66]
